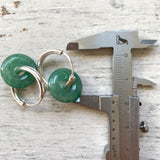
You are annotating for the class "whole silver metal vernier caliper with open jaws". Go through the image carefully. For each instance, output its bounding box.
[67,31,156,160]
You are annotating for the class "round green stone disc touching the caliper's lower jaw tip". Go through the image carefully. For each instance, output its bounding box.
[48,68,82,103]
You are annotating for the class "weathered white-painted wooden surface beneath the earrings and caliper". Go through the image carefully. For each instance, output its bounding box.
[0,0,160,160]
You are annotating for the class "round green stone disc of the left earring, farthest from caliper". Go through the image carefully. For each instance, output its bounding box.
[1,54,37,88]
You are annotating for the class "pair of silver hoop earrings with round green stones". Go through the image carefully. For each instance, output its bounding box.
[1,50,82,106]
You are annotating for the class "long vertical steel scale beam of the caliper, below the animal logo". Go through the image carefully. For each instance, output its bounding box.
[112,44,132,160]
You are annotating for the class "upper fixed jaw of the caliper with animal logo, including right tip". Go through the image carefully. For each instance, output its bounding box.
[66,31,157,50]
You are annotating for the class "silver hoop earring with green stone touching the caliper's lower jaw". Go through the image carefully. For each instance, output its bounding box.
[38,50,82,103]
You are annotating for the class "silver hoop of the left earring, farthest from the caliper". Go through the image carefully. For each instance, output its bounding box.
[11,66,45,107]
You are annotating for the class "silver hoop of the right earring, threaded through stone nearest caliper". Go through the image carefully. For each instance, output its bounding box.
[38,49,75,87]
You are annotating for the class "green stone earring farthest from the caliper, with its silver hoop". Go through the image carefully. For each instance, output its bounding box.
[1,54,45,106]
